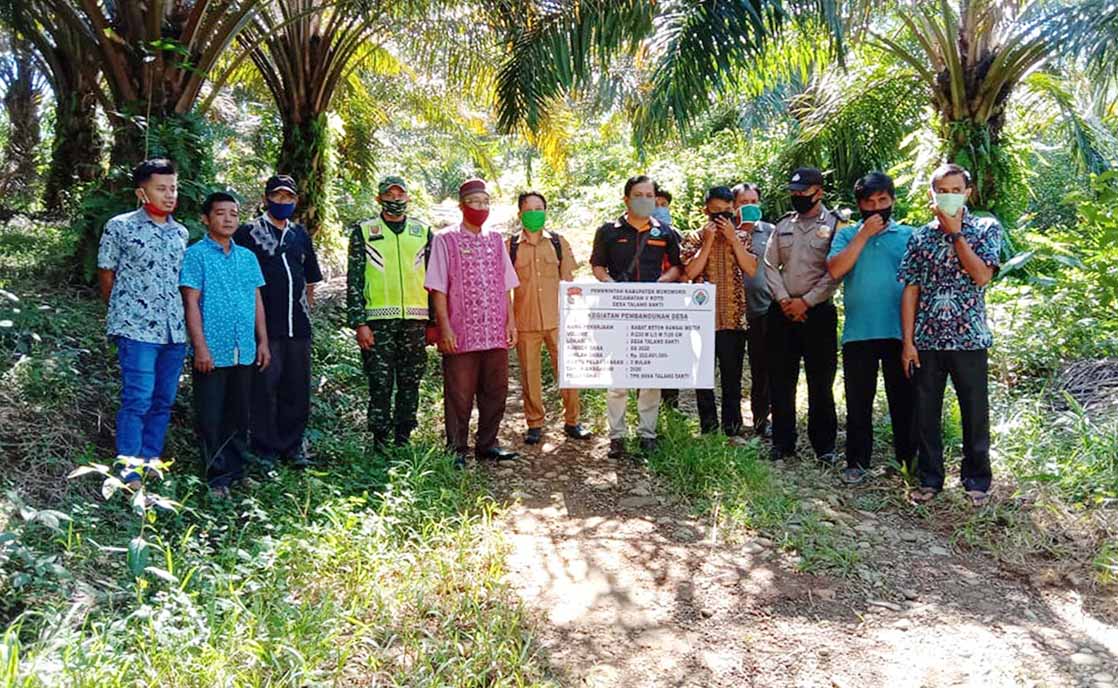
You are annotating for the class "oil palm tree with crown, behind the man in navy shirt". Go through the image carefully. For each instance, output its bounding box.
[231,0,494,234]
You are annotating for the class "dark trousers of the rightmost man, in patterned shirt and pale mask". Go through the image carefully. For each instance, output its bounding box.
[913,349,992,492]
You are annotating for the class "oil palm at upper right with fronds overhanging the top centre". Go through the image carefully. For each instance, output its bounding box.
[496,0,1118,210]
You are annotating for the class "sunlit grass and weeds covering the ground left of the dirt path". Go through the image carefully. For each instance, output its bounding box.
[0,223,559,688]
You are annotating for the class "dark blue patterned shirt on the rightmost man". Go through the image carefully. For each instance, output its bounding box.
[898,213,1002,351]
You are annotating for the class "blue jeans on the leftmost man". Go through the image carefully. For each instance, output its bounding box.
[116,337,187,459]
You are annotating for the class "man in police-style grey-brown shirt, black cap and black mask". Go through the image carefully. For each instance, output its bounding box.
[765,168,844,464]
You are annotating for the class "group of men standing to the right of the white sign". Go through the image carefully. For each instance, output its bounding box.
[661,164,1002,506]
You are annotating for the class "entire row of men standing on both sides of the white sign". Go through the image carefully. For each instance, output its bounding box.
[98,160,1001,505]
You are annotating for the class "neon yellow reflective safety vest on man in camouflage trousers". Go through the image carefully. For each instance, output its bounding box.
[361,217,430,320]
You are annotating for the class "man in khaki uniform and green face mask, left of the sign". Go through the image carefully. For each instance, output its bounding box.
[509,191,591,444]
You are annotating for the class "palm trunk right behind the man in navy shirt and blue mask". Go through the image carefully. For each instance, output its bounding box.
[276,113,337,236]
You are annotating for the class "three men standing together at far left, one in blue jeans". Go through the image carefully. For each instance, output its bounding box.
[97,159,322,498]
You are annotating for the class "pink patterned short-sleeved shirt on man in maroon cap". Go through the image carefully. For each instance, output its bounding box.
[424,225,520,354]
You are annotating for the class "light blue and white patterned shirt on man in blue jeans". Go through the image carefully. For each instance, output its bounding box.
[97,208,189,343]
